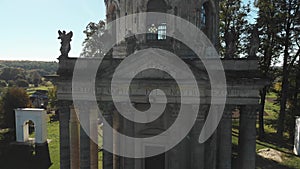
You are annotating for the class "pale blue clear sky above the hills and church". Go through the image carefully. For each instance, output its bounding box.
[0,0,253,61]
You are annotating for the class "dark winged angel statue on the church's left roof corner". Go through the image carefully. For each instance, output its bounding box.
[58,30,73,57]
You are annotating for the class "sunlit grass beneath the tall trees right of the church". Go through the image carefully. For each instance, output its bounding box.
[232,93,300,169]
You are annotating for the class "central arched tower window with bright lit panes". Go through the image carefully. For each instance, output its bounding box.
[147,0,167,41]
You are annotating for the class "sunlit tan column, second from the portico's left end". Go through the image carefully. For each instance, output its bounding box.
[69,106,80,169]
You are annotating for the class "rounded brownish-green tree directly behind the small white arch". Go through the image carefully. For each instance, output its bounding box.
[0,87,31,129]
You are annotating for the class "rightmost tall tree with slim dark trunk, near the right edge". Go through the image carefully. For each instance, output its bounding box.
[276,0,300,138]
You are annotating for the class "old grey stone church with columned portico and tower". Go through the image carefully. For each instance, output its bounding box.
[56,0,266,169]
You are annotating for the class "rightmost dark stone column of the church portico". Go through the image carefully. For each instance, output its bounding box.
[238,106,257,169]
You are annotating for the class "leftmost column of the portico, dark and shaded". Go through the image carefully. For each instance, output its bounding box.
[58,100,71,169]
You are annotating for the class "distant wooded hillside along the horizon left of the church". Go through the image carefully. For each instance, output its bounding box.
[0,60,58,75]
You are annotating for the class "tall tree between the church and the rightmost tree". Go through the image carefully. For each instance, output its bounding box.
[255,0,281,139]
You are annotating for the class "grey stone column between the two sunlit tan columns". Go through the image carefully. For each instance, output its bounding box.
[79,103,91,169]
